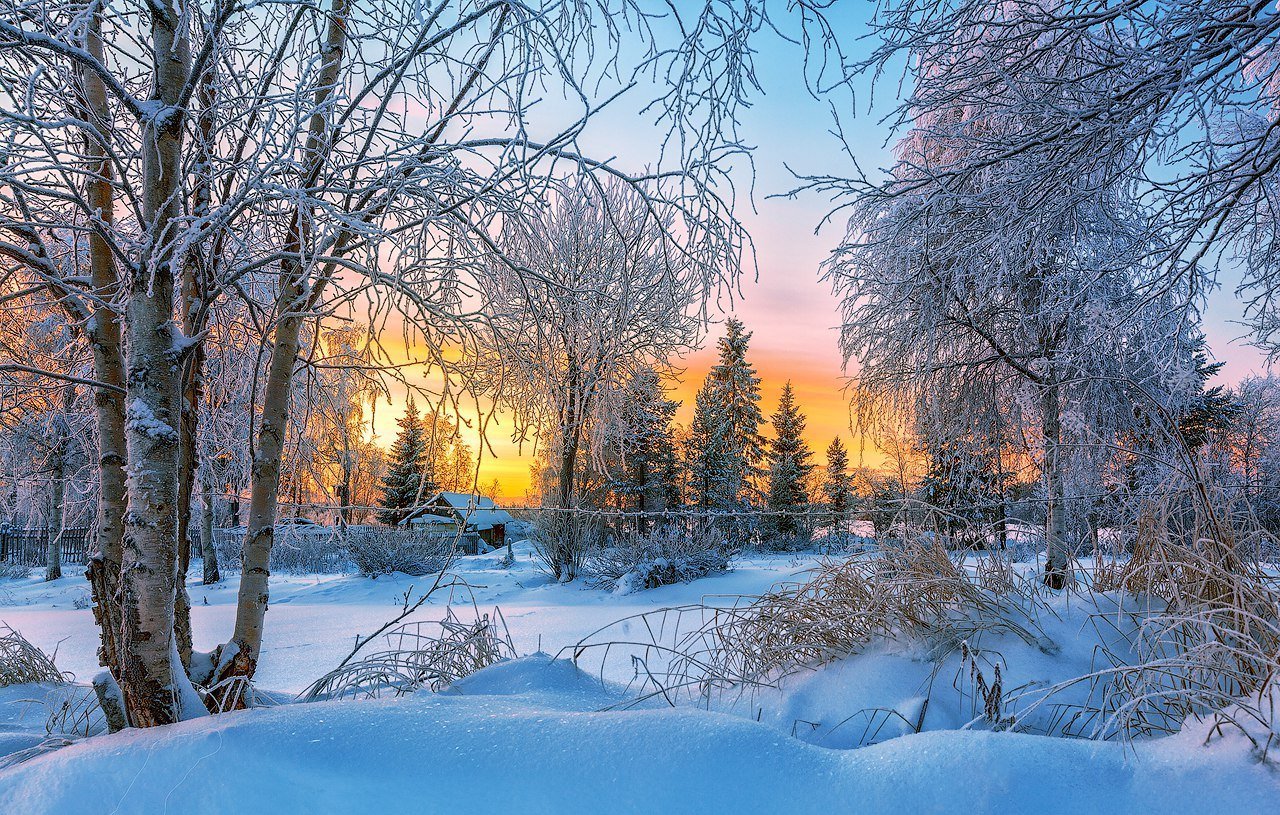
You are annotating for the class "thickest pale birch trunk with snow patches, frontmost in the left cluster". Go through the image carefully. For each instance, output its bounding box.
[119,5,202,727]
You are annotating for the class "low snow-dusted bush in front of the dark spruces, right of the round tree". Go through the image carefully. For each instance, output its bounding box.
[585,525,739,594]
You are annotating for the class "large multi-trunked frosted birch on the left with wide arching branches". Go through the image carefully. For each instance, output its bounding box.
[0,0,788,725]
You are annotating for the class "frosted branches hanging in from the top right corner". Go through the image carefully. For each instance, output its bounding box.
[836,0,1280,349]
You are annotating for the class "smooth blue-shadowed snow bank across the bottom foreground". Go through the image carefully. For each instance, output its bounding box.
[0,655,1280,815]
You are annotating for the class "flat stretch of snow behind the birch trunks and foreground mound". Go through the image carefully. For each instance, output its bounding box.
[0,544,818,692]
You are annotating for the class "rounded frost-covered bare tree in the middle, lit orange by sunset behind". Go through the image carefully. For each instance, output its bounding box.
[480,175,730,577]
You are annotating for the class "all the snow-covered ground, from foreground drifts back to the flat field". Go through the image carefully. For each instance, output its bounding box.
[0,537,1280,815]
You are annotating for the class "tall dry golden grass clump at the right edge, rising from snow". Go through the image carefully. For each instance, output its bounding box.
[1064,494,1280,738]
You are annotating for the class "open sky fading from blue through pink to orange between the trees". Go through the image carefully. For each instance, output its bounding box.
[375,4,1265,502]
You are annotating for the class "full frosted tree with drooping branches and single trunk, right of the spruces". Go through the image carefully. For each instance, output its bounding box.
[826,6,1189,587]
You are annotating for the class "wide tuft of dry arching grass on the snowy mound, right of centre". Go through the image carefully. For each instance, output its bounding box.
[572,544,1057,704]
